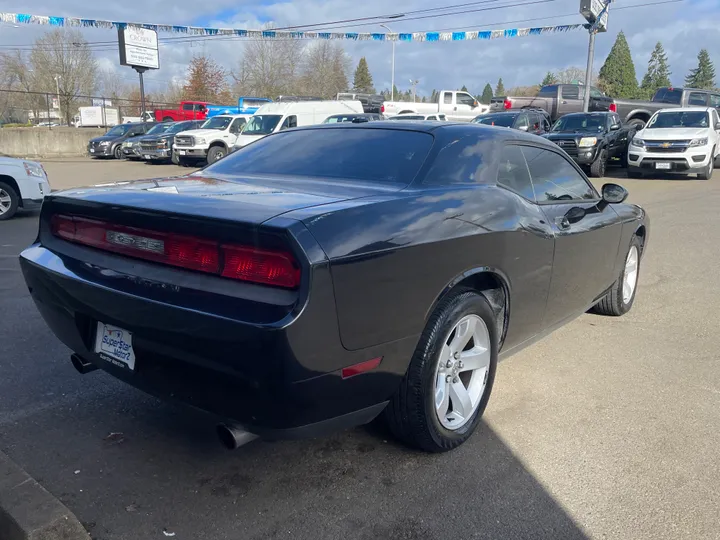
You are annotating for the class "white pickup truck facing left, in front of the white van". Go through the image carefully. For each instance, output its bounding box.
[173,114,252,165]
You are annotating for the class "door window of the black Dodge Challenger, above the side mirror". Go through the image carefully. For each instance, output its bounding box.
[522,146,599,203]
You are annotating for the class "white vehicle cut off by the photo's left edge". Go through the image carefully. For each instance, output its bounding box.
[0,157,50,221]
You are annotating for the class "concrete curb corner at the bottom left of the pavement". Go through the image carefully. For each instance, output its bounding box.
[0,452,90,540]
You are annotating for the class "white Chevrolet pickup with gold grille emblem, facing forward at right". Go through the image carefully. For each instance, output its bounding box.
[628,107,720,180]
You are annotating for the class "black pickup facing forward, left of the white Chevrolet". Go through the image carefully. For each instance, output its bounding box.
[545,112,636,178]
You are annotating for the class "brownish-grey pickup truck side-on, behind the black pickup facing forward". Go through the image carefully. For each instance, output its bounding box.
[490,84,615,122]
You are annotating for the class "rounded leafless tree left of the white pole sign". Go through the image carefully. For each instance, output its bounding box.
[30,29,98,125]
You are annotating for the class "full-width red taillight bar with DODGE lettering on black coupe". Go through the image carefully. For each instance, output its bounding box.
[50,215,300,289]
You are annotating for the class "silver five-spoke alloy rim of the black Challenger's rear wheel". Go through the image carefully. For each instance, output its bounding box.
[433,315,491,431]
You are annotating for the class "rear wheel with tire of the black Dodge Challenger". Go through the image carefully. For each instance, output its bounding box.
[385,289,498,452]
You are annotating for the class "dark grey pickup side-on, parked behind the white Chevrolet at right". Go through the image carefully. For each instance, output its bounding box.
[615,87,720,130]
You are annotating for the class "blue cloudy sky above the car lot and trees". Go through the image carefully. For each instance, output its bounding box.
[0,0,720,94]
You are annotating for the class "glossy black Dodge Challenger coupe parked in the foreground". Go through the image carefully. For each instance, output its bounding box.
[20,122,649,452]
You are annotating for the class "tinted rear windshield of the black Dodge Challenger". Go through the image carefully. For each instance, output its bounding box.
[204,126,433,184]
